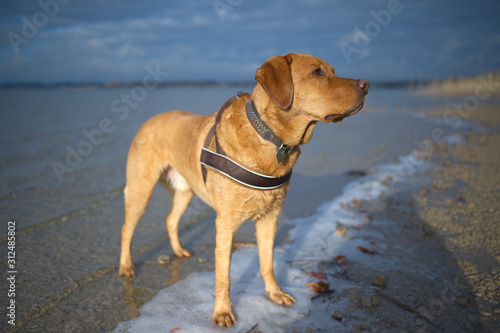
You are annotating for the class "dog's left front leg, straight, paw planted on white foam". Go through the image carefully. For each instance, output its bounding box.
[212,216,241,327]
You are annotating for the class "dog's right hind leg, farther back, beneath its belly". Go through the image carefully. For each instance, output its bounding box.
[163,167,194,258]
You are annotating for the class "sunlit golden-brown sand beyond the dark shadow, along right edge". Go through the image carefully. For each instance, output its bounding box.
[415,106,500,332]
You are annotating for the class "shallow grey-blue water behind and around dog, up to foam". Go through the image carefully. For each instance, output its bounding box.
[0,87,462,330]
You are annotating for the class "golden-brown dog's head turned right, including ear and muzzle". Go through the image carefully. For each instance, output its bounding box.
[255,53,368,123]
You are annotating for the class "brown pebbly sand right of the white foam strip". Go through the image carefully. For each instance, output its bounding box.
[339,105,500,332]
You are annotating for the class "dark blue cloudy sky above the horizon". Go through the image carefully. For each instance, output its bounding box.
[0,0,500,84]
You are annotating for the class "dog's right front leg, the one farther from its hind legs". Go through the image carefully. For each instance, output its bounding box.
[255,214,295,305]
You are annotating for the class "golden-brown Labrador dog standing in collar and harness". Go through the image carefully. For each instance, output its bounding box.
[119,53,369,327]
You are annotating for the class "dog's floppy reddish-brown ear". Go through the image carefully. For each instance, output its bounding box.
[255,55,293,111]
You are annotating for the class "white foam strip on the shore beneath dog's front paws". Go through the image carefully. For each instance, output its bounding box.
[115,156,429,333]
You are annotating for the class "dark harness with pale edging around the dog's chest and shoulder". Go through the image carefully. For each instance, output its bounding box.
[200,93,292,190]
